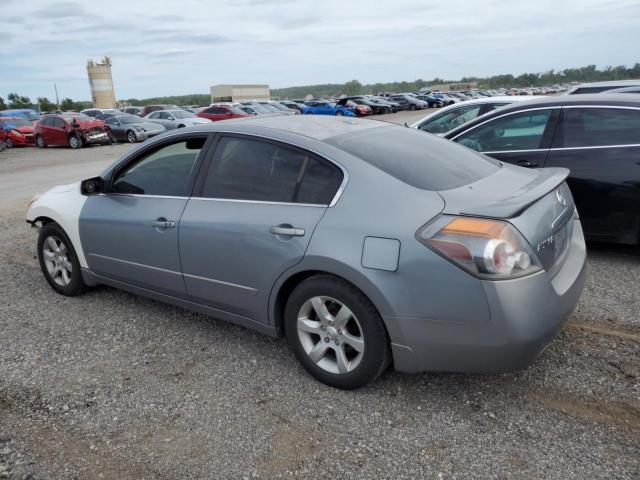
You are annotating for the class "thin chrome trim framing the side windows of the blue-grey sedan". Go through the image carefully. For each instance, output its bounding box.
[101,130,349,208]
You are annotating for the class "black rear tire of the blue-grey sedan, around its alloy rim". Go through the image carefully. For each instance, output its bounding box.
[284,275,391,390]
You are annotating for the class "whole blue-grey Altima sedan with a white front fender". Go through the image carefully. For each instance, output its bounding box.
[27,115,586,389]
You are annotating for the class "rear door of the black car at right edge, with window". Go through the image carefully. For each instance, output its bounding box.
[546,105,640,244]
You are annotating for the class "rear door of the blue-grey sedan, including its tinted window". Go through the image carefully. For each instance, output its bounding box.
[180,134,344,323]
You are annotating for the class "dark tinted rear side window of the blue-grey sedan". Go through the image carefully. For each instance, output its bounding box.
[202,137,342,205]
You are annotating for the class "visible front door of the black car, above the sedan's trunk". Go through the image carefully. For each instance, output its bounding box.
[452,107,560,167]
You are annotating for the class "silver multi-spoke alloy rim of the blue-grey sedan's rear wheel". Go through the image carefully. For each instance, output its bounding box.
[297,296,365,374]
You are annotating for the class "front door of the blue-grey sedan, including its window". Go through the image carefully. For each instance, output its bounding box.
[80,134,207,298]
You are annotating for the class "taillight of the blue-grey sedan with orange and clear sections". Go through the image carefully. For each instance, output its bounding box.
[417,215,542,280]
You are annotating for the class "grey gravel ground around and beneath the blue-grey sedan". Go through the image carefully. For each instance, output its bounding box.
[0,117,640,479]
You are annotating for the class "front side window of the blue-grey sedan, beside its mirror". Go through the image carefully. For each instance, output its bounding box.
[110,137,205,197]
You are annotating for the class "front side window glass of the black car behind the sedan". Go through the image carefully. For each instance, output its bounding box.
[455,110,551,152]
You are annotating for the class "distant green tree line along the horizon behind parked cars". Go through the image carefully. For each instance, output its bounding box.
[0,63,640,112]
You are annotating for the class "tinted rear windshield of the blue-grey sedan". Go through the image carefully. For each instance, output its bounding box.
[325,126,500,191]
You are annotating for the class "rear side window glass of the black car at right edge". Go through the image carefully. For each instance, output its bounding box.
[558,108,640,147]
